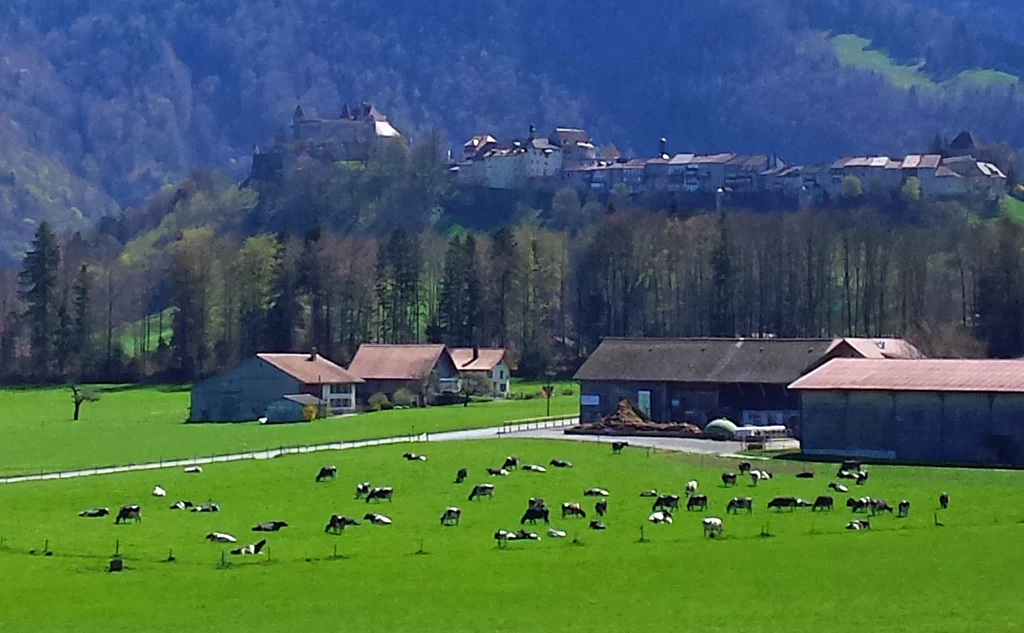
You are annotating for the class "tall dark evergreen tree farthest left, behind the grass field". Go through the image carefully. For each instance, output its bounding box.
[19,221,60,380]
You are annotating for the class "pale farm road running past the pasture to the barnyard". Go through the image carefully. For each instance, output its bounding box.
[0,418,741,484]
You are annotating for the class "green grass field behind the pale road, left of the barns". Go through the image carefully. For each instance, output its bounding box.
[0,387,580,474]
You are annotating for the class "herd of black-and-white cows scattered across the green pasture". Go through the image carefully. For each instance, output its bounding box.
[72,441,949,555]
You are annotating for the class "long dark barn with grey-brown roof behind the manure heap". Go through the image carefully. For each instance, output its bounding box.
[575,338,921,430]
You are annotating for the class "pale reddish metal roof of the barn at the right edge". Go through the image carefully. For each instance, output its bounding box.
[790,358,1024,393]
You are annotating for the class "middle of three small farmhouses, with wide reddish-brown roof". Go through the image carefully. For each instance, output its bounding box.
[348,345,462,406]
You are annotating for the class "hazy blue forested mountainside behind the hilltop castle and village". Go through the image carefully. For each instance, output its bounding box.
[0,0,1024,261]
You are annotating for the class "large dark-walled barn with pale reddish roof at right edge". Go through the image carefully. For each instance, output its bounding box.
[790,360,1024,465]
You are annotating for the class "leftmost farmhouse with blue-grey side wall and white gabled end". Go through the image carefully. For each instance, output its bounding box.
[188,349,362,422]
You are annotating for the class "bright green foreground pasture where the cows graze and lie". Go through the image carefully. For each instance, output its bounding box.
[0,439,1024,633]
